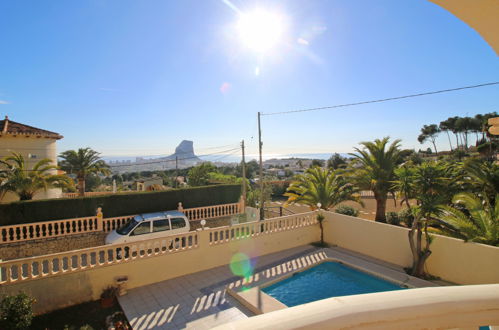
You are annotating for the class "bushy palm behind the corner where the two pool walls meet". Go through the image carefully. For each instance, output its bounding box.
[284,167,363,245]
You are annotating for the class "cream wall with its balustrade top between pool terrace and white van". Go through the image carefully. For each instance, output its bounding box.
[0,212,319,313]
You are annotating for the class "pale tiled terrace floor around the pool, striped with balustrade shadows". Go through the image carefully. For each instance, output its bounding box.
[119,246,434,330]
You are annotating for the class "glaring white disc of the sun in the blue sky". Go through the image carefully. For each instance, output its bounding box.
[237,9,285,53]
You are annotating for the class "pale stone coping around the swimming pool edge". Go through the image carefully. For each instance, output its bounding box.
[226,248,438,314]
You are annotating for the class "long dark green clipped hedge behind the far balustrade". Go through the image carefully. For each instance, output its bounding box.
[0,185,241,225]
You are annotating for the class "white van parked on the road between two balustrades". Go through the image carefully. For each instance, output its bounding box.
[106,211,191,244]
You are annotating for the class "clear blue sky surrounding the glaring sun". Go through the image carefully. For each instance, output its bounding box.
[0,0,499,160]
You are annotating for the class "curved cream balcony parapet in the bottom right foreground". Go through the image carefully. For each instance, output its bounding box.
[215,284,499,330]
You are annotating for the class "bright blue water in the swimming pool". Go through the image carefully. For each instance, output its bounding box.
[262,262,405,307]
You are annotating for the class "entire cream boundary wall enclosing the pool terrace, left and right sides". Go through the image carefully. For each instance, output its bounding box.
[0,212,499,312]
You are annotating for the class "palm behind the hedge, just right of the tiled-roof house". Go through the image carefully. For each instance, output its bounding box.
[59,148,111,196]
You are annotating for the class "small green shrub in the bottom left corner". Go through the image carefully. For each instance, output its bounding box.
[0,292,35,330]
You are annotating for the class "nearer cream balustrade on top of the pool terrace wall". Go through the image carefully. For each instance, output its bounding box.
[0,212,317,285]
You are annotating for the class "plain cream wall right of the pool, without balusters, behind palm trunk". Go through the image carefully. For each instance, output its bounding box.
[324,212,499,284]
